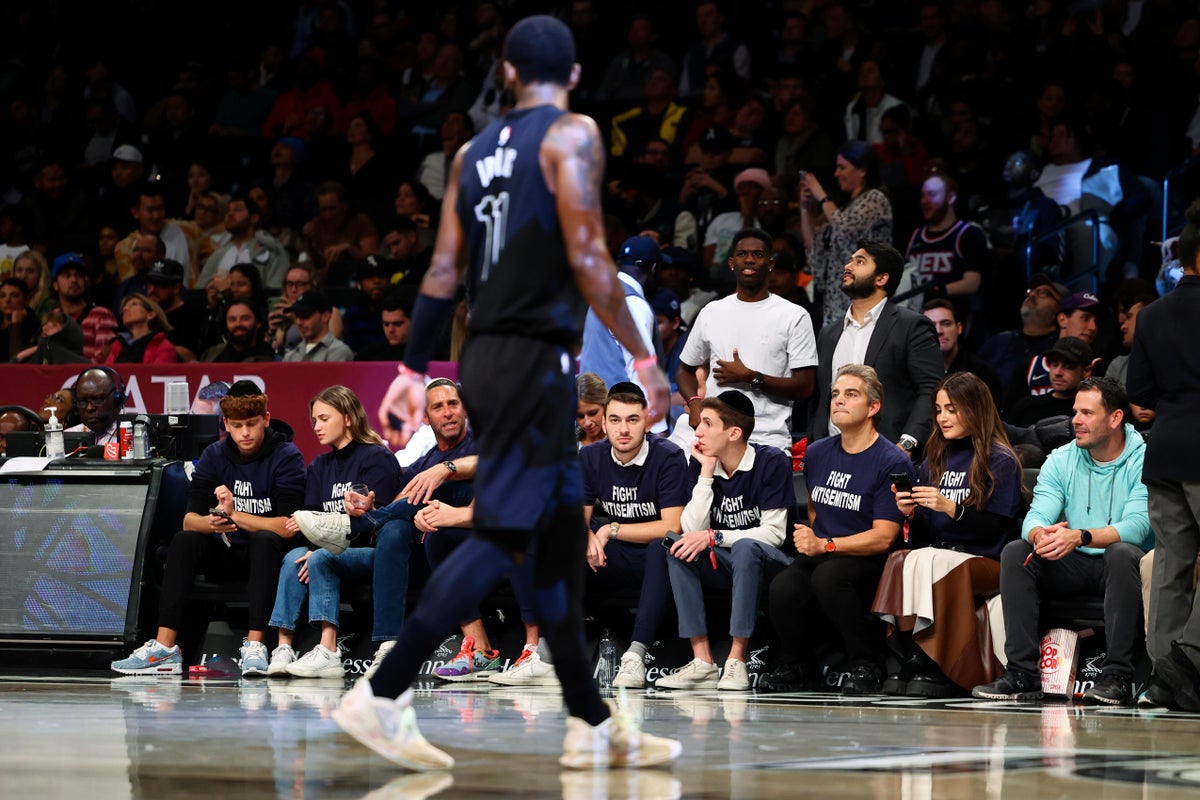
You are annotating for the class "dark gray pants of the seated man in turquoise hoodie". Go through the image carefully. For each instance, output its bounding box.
[1000,539,1145,679]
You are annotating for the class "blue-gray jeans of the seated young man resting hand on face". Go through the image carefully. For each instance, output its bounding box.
[667,539,792,639]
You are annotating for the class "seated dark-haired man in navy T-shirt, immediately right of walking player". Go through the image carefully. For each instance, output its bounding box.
[580,381,691,688]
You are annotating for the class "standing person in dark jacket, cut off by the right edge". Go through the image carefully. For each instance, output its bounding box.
[1126,201,1200,711]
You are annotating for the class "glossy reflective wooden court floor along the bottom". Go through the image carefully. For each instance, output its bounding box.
[0,674,1200,800]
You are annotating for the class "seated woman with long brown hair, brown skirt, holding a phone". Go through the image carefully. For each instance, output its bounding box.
[872,372,1022,697]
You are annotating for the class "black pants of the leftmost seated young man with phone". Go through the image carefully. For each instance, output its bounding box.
[158,530,294,631]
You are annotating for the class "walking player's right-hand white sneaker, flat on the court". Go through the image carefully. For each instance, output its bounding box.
[558,700,681,769]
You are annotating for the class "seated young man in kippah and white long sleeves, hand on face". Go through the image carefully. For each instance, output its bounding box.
[656,390,796,692]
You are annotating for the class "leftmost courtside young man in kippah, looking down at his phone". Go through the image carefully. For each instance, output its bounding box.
[112,380,305,675]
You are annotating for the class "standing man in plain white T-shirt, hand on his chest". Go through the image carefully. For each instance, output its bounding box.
[672,228,817,455]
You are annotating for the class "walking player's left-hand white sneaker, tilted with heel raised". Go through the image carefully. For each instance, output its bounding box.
[332,678,454,772]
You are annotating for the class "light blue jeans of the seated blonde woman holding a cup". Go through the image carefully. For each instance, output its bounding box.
[270,547,374,631]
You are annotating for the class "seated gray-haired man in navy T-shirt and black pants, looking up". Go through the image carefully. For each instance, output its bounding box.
[763,363,913,694]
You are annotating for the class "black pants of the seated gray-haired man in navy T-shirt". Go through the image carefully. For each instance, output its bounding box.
[770,554,887,667]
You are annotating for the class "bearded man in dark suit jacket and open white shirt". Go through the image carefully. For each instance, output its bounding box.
[809,239,946,455]
